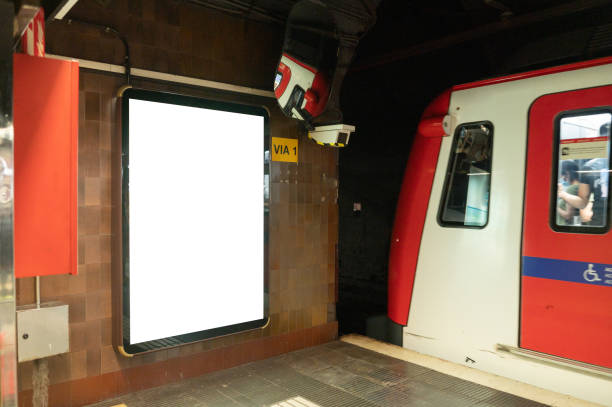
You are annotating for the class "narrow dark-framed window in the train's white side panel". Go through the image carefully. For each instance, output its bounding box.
[438,122,493,228]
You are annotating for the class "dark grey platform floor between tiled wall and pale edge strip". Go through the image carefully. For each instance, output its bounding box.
[85,341,544,407]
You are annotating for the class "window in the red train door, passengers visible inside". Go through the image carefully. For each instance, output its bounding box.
[551,110,612,233]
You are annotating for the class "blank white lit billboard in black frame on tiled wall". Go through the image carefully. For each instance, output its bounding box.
[122,89,268,353]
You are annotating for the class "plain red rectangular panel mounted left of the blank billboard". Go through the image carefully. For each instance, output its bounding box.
[13,54,79,278]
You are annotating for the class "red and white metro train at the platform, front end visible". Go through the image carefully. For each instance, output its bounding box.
[388,58,612,406]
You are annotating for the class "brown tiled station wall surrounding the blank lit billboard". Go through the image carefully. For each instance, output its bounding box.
[17,0,338,406]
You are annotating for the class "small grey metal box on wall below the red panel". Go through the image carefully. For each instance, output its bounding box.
[17,302,70,362]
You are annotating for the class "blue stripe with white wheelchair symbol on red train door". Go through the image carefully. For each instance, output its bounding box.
[523,256,612,287]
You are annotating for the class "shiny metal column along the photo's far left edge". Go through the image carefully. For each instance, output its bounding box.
[0,0,17,407]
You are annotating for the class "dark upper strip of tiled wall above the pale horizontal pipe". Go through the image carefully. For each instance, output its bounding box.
[46,0,283,89]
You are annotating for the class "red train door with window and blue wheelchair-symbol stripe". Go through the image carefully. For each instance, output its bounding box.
[520,86,612,368]
